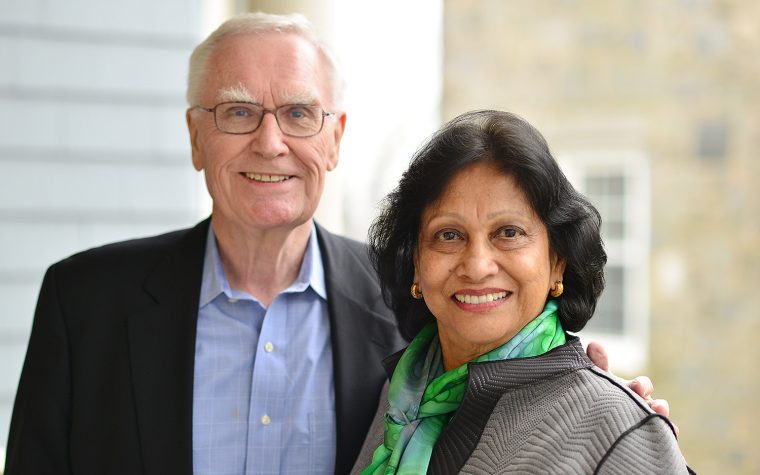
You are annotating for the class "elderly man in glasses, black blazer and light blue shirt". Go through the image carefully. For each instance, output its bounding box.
[6,14,668,475]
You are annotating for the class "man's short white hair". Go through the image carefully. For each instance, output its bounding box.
[187,12,344,110]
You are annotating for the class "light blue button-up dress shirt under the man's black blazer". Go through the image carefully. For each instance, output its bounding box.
[193,224,336,475]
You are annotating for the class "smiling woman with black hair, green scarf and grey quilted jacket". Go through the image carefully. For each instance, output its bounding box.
[355,111,689,474]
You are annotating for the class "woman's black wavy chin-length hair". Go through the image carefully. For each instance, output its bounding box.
[368,110,607,339]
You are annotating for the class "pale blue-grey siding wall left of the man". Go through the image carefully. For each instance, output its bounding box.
[0,0,203,452]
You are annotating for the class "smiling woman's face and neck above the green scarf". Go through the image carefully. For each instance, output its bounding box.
[415,163,565,370]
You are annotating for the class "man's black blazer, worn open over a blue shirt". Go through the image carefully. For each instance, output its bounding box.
[5,220,404,475]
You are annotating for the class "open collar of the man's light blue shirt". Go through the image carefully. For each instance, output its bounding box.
[199,218,327,307]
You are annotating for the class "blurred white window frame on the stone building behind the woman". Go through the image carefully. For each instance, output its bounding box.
[558,150,651,376]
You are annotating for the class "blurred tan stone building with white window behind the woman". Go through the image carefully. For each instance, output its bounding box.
[443,0,760,474]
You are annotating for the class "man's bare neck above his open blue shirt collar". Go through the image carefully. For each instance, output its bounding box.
[211,219,312,307]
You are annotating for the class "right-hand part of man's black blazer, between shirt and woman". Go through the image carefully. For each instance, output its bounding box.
[317,226,405,473]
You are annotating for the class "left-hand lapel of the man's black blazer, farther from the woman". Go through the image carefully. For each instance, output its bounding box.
[128,220,209,475]
